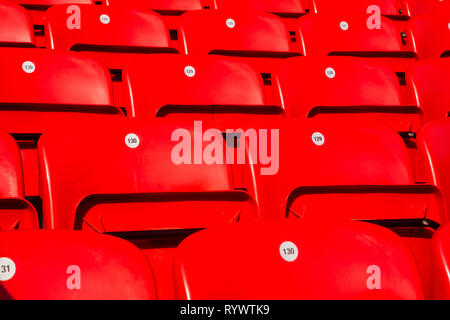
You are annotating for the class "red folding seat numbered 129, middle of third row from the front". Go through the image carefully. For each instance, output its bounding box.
[124,54,284,126]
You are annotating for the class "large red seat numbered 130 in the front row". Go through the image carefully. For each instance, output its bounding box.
[175,220,423,300]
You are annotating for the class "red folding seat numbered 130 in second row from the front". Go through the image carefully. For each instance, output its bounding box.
[39,119,259,298]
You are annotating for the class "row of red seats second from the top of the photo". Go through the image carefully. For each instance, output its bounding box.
[0,1,450,61]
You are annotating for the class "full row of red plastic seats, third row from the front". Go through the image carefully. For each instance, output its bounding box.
[0,48,450,134]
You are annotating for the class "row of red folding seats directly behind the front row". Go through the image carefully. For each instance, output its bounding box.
[0,118,450,297]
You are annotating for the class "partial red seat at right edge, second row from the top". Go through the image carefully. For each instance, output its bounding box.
[408,14,450,59]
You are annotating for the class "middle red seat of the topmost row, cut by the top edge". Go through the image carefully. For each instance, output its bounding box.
[218,0,314,18]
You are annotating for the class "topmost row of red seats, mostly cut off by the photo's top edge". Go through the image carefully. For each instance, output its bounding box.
[4,0,450,19]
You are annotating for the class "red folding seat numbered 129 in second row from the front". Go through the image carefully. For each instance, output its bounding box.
[250,119,442,294]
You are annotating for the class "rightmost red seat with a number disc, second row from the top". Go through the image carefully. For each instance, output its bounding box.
[298,12,416,75]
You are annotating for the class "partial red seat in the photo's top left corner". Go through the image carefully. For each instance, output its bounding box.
[0,1,35,48]
